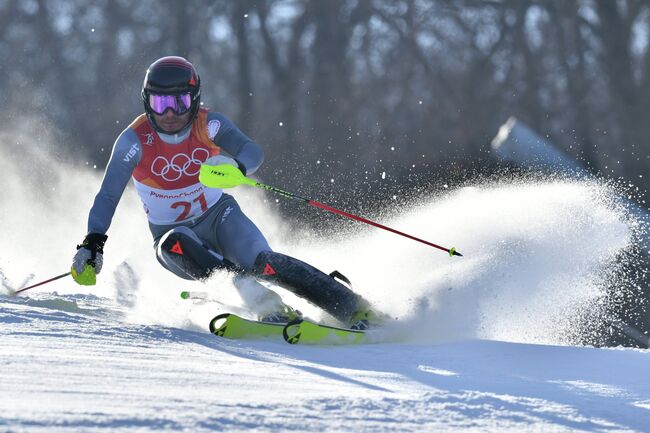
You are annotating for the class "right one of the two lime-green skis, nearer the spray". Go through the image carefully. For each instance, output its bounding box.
[282,319,371,345]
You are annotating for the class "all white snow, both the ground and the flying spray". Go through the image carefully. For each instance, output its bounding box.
[0,145,650,432]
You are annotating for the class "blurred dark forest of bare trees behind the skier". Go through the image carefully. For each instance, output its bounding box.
[5,0,650,211]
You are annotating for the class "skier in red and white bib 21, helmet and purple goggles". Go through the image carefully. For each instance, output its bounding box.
[71,56,378,329]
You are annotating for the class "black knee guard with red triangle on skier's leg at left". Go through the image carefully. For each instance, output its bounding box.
[156,226,229,280]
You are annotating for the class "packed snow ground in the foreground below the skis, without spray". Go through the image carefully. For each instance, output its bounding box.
[0,295,650,432]
